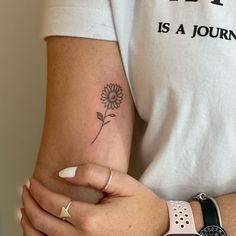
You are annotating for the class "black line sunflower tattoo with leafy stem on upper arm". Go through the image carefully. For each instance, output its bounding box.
[91,83,124,144]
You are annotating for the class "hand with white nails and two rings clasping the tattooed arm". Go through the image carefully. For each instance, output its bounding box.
[21,164,168,236]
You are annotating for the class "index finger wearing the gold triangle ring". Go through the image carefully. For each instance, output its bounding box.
[29,179,94,225]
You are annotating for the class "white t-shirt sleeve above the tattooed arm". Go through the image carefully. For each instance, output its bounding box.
[41,0,117,41]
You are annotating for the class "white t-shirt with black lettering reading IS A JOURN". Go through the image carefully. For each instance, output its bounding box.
[42,0,236,200]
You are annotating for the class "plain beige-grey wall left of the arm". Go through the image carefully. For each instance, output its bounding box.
[0,0,46,236]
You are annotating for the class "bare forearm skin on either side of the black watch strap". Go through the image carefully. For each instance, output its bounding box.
[191,194,236,236]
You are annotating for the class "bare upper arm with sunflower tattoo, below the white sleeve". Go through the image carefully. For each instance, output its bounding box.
[34,36,134,202]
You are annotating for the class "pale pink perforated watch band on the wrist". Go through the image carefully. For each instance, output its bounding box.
[165,201,199,236]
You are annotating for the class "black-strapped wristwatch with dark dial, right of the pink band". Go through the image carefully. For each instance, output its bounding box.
[194,193,227,236]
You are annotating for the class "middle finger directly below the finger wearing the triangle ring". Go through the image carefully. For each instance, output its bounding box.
[22,187,74,236]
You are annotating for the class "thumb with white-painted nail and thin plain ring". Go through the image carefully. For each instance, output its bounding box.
[59,163,141,197]
